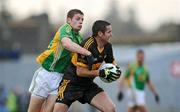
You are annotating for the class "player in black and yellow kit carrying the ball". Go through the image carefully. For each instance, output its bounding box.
[54,20,120,112]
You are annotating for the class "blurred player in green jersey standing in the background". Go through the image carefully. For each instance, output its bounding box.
[118,49,159,112]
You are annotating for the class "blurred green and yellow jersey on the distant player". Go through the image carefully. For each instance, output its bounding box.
[125,63,149,90]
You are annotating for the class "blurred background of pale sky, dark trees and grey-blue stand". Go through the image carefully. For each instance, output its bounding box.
[0,0,180,112]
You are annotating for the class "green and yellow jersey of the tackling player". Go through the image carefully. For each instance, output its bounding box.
[36,23,82,73]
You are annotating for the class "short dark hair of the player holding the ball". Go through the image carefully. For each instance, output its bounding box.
[92,20,111,37]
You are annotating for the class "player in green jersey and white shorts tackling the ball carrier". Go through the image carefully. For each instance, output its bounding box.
[28,9,91,112]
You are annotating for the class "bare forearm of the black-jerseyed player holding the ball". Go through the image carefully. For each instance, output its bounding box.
[76,67,99,77]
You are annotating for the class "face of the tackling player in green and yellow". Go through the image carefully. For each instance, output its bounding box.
[68,14,84,31]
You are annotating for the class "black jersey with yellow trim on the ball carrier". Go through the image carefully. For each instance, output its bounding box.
[64,37,115,85]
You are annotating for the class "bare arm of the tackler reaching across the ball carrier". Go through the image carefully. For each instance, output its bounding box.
[61,38,91,56]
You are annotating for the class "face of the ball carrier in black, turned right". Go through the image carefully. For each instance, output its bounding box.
[102,25,112,42]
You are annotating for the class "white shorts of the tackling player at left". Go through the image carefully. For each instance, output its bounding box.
[29,67,63,98]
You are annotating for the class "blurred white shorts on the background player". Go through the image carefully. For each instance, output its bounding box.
[126,88,145,107]
